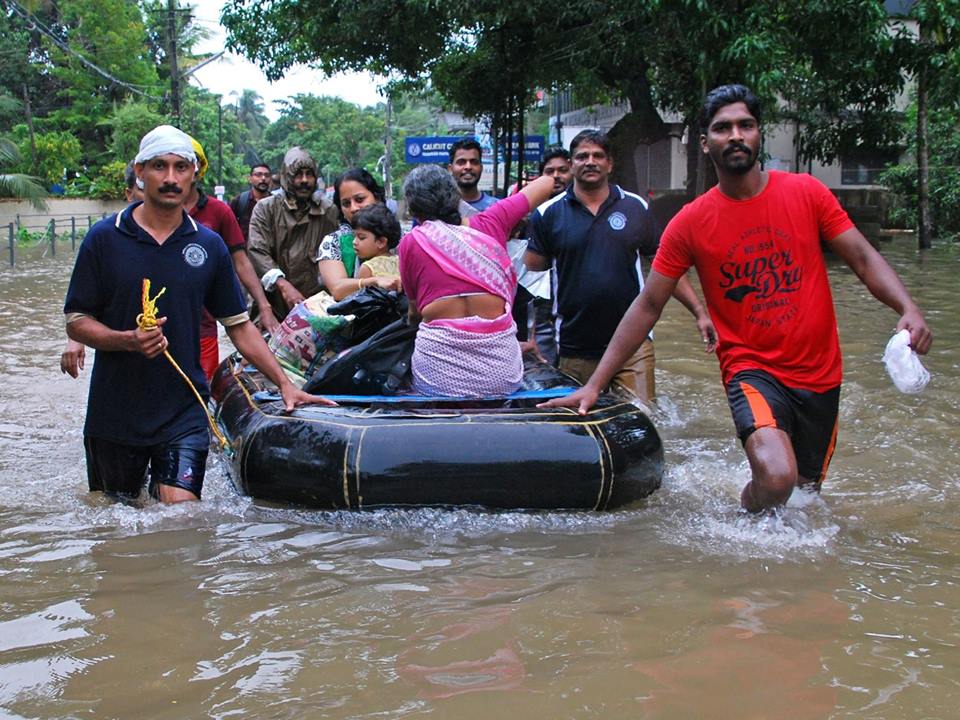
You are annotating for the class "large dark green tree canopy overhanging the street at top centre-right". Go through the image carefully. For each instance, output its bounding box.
[223,0,901,198]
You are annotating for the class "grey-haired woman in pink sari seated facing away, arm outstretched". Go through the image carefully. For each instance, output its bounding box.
[398,165,553,397]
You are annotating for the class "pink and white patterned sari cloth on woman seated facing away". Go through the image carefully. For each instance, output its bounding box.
[410,220,523,397]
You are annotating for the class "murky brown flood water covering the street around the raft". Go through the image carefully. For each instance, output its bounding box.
[0,239,960,720]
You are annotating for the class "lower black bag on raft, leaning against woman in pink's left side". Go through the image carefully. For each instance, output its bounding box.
[303,317,417,395]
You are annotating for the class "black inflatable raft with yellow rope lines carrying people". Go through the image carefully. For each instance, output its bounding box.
[212,359,663,510]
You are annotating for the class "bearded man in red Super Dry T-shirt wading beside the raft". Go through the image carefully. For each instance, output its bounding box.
[544,85,933,512]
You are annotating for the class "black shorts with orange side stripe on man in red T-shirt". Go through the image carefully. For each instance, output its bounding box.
[727,370,840,485]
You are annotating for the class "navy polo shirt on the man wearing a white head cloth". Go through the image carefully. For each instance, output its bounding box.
[63,203,246,446]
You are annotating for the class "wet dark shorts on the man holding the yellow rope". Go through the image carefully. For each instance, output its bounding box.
[83,428,210,500]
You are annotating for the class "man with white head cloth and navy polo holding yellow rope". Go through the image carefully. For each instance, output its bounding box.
[64,125,331,502]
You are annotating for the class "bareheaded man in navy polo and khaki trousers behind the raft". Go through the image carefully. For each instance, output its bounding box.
[524,130,716,402]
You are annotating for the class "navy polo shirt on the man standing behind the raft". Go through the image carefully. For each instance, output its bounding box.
[527,184,660,358]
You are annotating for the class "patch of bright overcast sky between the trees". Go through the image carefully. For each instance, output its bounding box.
[190,0,383,120]
